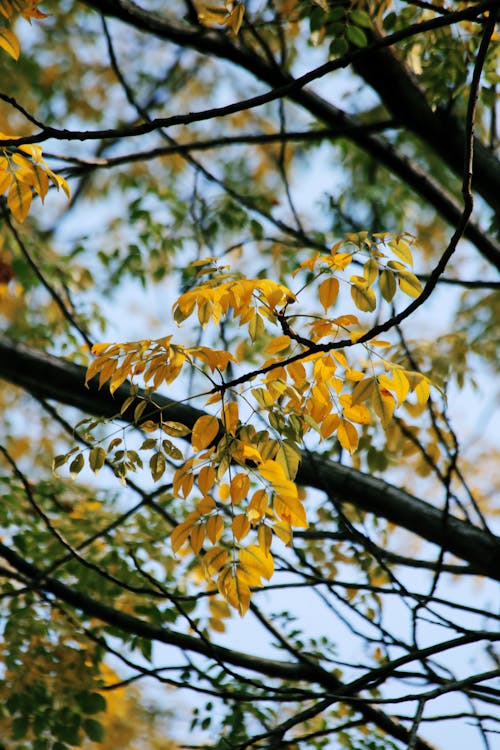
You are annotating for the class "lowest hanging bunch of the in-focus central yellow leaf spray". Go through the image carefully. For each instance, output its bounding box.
[171,402,300,615]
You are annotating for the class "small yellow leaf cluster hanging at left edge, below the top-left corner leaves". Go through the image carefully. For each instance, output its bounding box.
[0,133,70,221]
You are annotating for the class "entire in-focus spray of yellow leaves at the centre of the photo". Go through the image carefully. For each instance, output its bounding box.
[78,232,430,615]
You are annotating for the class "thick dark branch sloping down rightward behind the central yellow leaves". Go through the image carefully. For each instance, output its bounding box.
[0,335,500,580]
